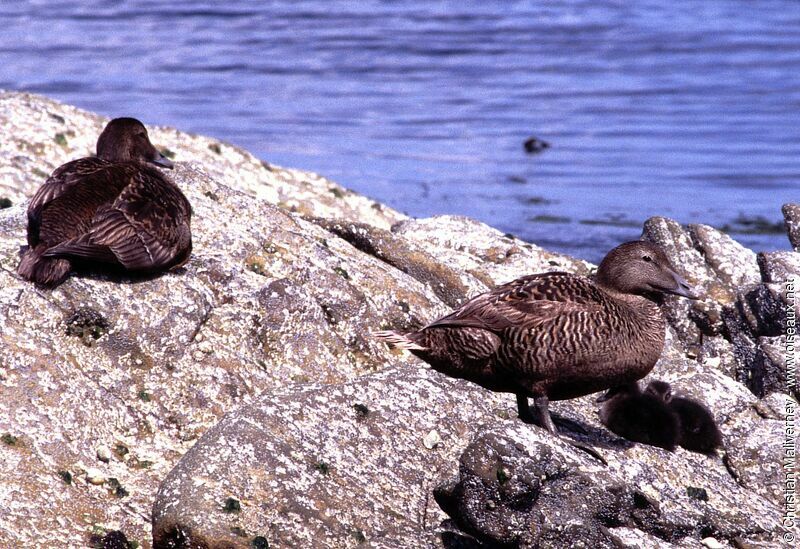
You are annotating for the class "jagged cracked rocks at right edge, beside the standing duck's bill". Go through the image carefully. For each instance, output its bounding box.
[643,216,800,404]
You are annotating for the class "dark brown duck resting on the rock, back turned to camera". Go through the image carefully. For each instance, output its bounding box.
[17,118,192,286]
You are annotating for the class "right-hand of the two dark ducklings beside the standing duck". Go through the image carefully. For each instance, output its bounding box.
[645,381,722,455]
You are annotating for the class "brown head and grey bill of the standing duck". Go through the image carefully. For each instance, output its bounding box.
[595,240,699,299]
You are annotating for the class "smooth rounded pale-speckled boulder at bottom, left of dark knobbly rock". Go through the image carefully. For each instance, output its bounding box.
[153,367,511,547]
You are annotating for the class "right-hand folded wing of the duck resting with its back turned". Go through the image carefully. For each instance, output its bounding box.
[44,167,191,271]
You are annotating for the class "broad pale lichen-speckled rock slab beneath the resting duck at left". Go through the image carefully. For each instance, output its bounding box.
[0,163,447,546]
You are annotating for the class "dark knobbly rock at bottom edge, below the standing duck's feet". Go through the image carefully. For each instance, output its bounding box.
[434,432,660,547]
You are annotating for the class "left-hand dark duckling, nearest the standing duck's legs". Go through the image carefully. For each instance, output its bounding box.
[597,382,681,451]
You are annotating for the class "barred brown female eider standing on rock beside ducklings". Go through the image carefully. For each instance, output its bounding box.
[374,241,697,440]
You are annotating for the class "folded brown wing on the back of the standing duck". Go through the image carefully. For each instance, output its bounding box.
[425,273,603,333]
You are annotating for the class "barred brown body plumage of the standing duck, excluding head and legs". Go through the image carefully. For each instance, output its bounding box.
[390,273,665,400]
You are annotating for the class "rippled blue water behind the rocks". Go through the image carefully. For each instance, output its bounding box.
[0,0,800,260]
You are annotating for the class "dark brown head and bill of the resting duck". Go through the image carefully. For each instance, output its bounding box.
[97,118,174,169]
